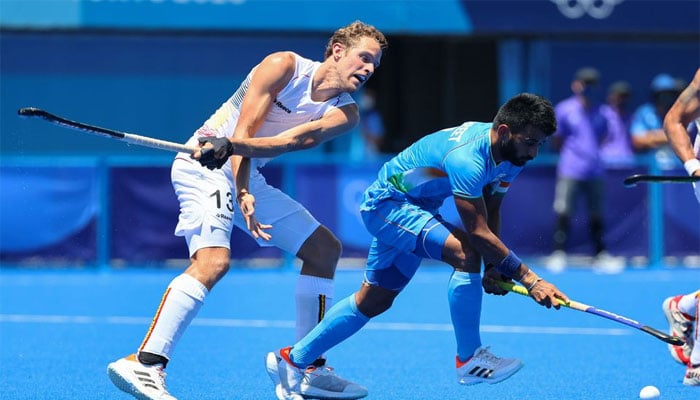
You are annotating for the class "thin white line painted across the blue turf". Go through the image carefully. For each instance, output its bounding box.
[0,314,631,336]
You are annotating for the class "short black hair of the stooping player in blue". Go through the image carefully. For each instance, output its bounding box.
[493,93,557,136]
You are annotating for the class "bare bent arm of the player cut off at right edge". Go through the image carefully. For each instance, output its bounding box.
[664,68,700,176]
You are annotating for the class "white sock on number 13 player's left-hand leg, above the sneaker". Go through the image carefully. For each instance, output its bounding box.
[139,274,209,360]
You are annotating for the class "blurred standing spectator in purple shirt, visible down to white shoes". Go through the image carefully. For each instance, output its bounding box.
[547,67,609,271]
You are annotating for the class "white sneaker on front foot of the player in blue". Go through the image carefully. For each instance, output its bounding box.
[456,347,523,385]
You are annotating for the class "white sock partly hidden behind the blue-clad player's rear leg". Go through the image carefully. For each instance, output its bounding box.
[294,275,333,341]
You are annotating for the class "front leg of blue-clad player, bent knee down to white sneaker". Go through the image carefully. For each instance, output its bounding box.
[419,218,522,385]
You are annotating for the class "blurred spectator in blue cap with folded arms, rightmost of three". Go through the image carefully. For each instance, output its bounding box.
[630,74,682,169]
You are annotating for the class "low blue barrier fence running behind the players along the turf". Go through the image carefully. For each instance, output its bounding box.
[0,156,700,267]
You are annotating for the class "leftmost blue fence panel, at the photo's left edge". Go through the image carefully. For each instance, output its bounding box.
[0,161,100,265]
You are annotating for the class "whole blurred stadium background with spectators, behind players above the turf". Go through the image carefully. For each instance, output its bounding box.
[0,0,700,268]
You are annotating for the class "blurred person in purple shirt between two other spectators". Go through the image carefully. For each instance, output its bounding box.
[600,81,634,168]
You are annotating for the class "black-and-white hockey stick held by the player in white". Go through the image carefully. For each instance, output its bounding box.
[17,107,196,154]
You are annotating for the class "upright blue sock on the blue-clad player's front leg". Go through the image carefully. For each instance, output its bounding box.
[447,271,482,361]
